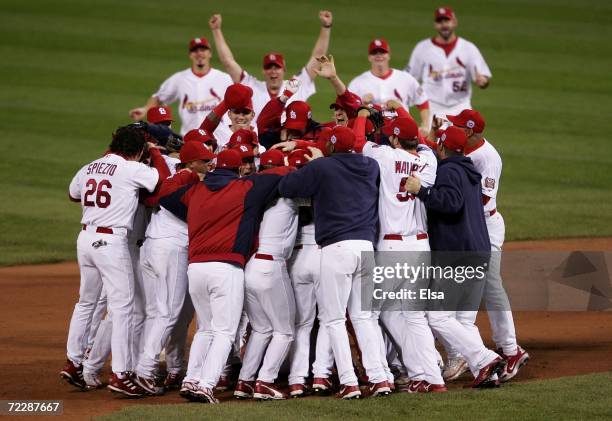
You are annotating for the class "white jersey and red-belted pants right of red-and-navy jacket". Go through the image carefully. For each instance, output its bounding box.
[239,198,298,383]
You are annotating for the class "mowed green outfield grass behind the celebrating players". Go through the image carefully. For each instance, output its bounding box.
[0,0,612,265]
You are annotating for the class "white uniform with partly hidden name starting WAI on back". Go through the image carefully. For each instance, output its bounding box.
[362,142,444,384]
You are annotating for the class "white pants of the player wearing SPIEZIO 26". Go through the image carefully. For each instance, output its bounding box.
[67,227,134,373]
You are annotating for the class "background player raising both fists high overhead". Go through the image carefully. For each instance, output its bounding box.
[209,10,332,115]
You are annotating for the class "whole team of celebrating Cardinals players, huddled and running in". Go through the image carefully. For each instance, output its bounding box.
[60,7,529,403]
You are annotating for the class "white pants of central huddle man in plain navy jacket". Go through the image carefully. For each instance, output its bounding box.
[316,240,388,386]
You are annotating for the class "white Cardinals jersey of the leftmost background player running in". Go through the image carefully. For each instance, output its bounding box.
[153,68,233,135]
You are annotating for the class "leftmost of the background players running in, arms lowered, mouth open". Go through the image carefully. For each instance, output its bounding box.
[130,38,232,135]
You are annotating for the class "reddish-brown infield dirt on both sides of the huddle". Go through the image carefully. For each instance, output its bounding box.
[0,238,612,419]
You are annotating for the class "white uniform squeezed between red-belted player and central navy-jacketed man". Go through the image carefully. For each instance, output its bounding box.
[288,199,334,385]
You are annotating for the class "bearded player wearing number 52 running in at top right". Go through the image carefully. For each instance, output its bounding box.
[406,7,491,117]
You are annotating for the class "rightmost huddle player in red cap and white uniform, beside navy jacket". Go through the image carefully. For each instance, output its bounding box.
[440,110,529,382]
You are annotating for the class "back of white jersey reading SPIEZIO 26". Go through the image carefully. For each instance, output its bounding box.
[70,153,159,230]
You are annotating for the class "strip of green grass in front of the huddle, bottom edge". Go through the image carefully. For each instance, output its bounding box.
[101,373,612,421]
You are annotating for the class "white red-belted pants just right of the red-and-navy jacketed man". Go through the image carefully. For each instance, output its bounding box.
[239,253,295,383]
